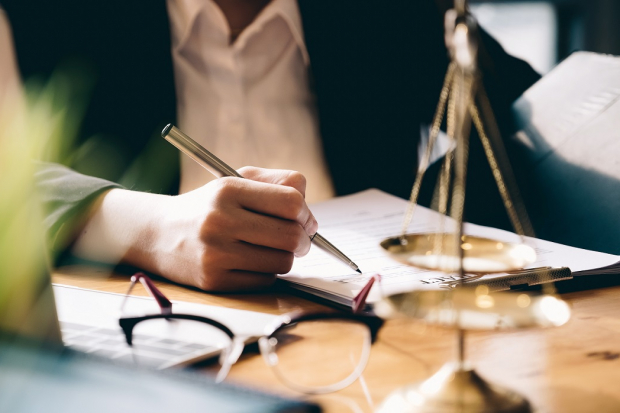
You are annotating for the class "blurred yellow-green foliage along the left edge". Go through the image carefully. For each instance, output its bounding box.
[0,73,83,338]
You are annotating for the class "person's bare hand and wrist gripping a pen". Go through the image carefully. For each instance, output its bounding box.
[74,167,318,291]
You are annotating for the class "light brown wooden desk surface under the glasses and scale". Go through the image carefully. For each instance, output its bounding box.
[53,267,620,413]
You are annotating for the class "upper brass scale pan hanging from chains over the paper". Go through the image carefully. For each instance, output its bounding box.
[381,233,536,274]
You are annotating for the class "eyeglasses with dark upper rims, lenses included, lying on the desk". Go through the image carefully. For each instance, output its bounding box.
[119,273,383,394]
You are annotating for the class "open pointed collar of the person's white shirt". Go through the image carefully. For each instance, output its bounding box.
[171,0,310,65]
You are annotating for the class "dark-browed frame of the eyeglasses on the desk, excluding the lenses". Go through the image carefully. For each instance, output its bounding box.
[118,272,384,394]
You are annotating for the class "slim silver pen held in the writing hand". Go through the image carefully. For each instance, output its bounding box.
[161,123,362,274]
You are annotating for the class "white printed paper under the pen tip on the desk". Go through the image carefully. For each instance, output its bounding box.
[280,189,620,305]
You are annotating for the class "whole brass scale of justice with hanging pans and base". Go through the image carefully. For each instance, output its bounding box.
[375,0,570,413]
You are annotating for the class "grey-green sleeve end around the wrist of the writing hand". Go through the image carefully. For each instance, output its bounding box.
[35,162,122,256]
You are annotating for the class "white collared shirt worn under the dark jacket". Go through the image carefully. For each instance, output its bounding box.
[167,0,334,202]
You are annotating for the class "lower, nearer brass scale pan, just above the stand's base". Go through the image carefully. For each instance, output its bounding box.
[374,286,571,331]
